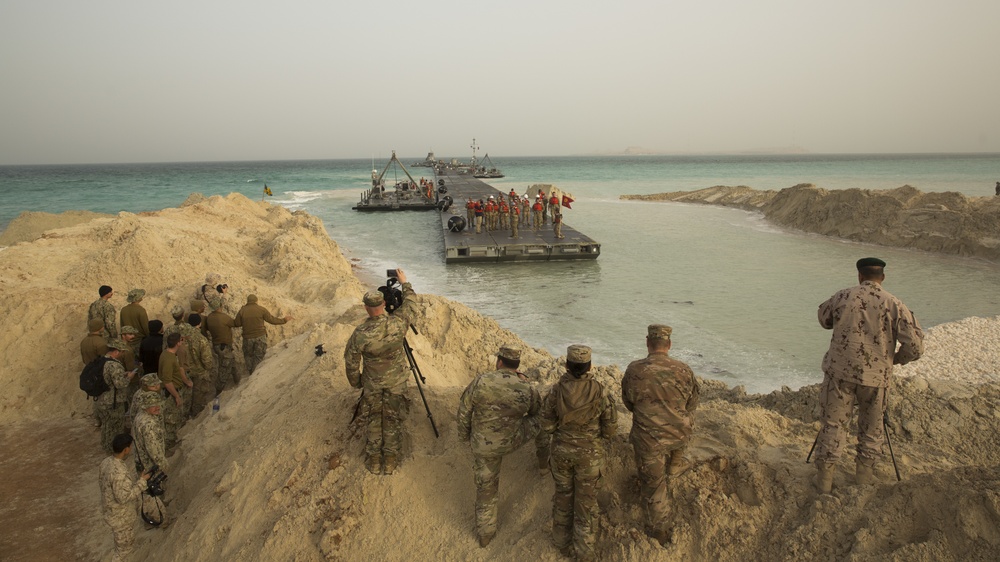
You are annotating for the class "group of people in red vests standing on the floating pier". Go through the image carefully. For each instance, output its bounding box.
[465,189,565,238]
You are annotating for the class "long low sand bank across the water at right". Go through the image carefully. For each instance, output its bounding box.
[621,184,1000,260]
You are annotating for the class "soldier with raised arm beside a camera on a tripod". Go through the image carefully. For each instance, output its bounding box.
[344,269,416,474]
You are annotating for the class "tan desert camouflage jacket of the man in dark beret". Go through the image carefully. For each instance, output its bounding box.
[817,281,924,388]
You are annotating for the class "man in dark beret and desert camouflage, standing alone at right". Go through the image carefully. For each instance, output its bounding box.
[816,258,924,493]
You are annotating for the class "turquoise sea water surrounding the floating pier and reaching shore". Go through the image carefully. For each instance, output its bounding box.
[0,154,1000,391]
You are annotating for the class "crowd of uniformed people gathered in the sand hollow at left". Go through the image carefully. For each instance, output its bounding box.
[91,274,292,559]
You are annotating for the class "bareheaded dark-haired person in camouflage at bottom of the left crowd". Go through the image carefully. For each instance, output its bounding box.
[98,433,150,562]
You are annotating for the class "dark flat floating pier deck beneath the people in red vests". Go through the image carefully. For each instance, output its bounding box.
[437,169,601,263]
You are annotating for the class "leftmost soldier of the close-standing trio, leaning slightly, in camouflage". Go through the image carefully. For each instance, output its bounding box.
[458,346,541,547]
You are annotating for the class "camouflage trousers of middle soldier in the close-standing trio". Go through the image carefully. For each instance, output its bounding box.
[550,449,602,560]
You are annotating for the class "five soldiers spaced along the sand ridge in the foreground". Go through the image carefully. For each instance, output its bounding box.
[344,258,923,560]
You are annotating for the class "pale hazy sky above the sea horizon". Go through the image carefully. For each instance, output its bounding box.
[0,0,1000,164]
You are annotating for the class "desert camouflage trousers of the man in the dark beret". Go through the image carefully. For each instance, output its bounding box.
[816,375,886,466]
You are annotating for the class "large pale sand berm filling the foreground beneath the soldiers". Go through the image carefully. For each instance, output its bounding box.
[0,194,1000,562]
